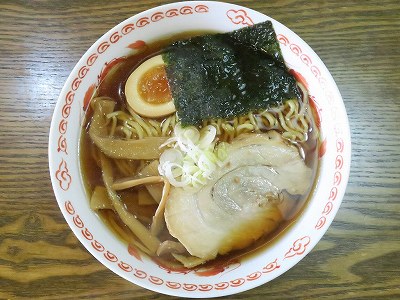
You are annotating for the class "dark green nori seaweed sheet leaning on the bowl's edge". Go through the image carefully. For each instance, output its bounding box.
[163,21,300,126]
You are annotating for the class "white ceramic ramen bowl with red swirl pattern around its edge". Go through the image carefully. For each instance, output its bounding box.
[49,1,350,298]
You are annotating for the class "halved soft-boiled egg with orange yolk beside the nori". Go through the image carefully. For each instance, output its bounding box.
[125,55,176,117]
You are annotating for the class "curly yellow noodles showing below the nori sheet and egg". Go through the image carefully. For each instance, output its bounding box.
[101,84,311,146]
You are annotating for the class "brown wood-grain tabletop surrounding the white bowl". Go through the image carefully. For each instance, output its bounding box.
[0,0,400,299]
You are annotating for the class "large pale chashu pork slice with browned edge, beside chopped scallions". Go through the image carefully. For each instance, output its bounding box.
[165,134,312,262]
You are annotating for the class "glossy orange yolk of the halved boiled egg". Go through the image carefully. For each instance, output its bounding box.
[138,66,172,104]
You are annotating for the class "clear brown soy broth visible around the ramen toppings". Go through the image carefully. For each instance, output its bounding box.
[79,31,318,269]
